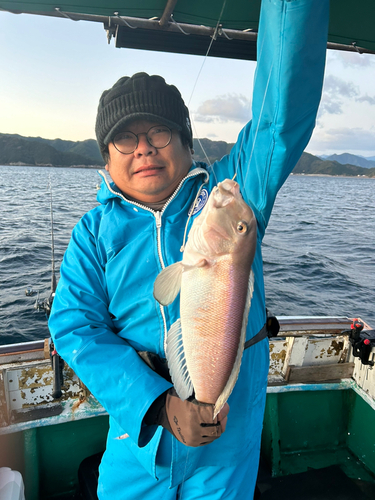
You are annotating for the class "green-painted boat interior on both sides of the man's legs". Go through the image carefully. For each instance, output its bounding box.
[0,389,375,500]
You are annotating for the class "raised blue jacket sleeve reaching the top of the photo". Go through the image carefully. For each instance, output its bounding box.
[229,0,329,236]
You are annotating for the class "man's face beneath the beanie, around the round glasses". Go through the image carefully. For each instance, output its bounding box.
[105,120,192,203]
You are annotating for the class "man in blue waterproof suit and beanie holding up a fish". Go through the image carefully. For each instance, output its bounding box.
[50,0,329,500]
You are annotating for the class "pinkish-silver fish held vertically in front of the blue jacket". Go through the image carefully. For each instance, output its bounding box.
[154,179,257,418]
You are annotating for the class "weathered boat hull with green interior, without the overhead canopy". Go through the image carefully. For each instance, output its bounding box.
[0,316,375,500]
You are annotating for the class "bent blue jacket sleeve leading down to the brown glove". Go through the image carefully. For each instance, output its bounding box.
[49,212,171,446]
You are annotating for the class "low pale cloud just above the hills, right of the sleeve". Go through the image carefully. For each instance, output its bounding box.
[308,127,375,152]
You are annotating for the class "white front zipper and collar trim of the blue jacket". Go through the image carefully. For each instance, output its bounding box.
[98,167,209,358]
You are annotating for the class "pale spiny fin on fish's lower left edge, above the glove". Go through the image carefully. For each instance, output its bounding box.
[166,319,194,401]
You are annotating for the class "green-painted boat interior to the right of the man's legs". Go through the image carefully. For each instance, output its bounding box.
[262,389,375,482]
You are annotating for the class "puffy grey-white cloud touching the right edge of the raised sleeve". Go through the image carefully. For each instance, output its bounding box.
[318,75,359,118]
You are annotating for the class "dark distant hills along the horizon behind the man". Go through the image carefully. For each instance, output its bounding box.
[0,134,375,177]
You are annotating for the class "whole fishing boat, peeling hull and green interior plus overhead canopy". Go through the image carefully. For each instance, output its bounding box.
[0,0,375,500]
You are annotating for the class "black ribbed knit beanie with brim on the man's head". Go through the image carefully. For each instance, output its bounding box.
[95,73,193,157]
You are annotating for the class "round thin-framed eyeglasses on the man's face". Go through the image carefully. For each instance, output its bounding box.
[112,125,172,155]
